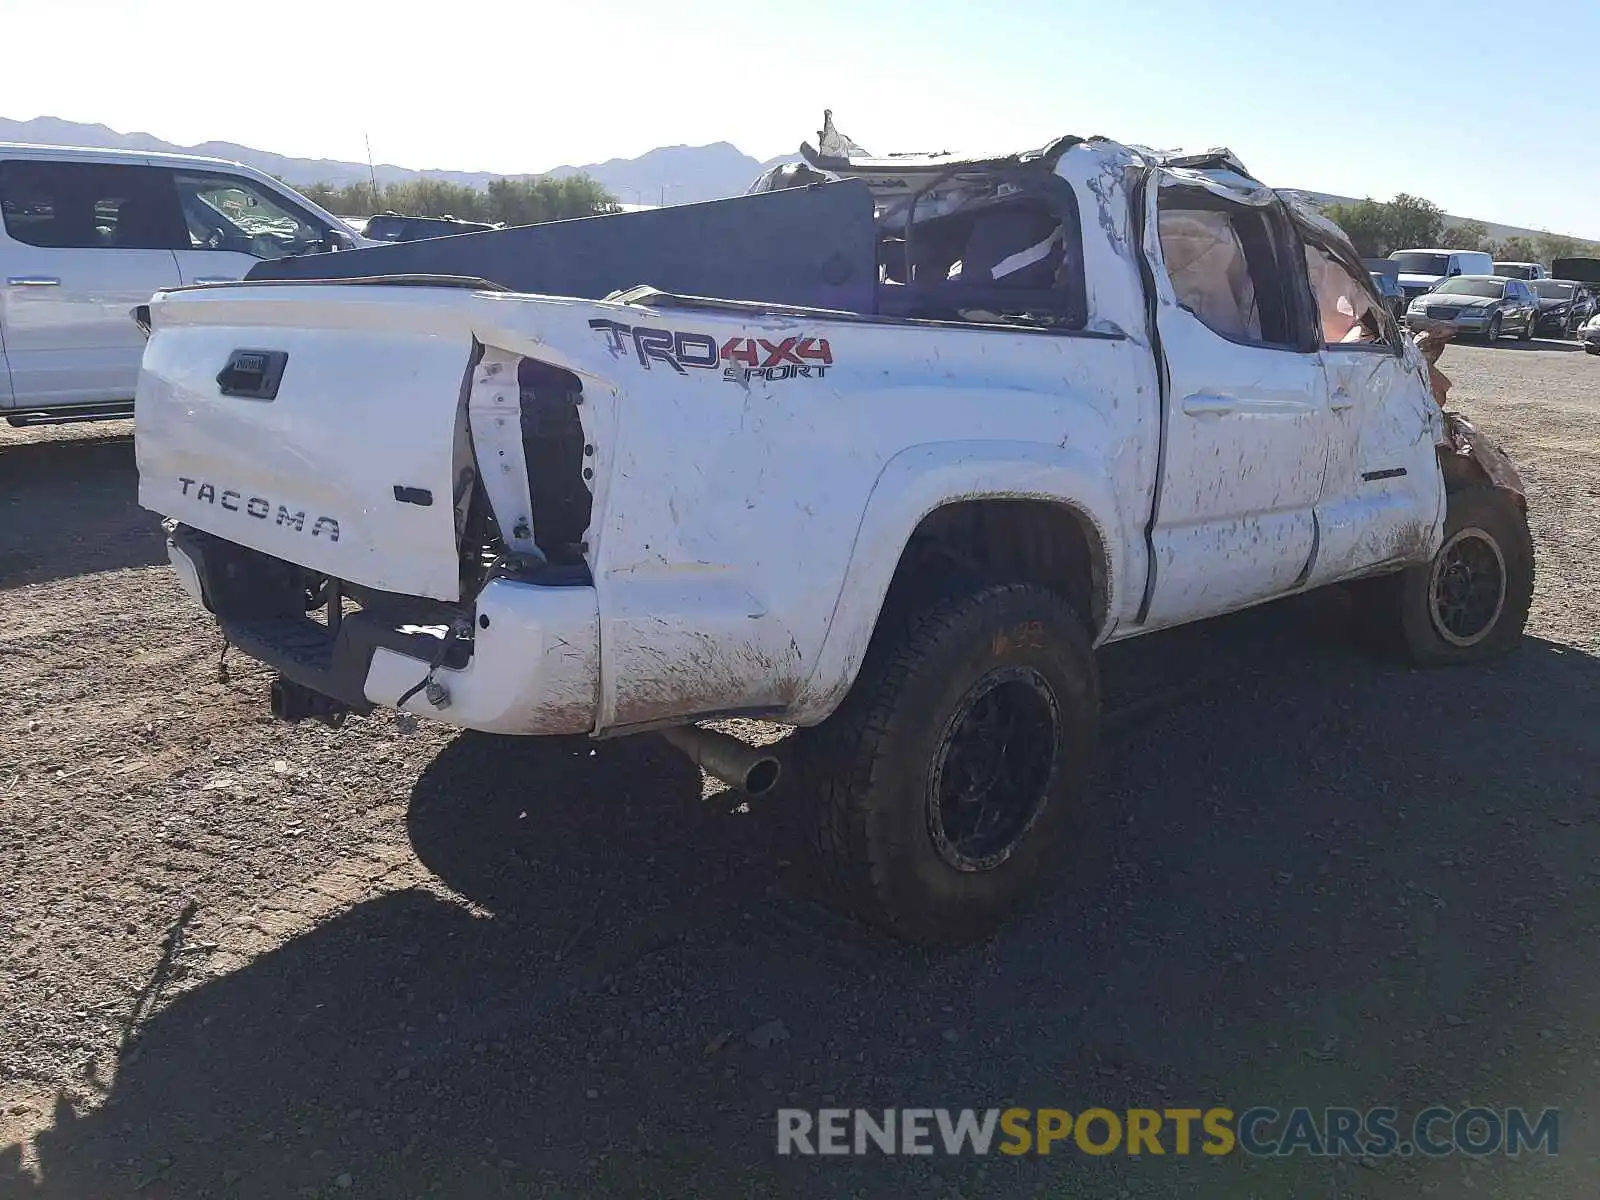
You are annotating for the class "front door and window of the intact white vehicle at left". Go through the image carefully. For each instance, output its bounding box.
[163,168,337,283]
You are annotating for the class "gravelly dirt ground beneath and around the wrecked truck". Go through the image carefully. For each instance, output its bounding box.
[0,342,1600,1200]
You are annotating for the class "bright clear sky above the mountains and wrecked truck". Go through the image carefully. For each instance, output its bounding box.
[0,0,1600,238]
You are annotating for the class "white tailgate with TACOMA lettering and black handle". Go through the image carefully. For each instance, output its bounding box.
[134,285,472,600]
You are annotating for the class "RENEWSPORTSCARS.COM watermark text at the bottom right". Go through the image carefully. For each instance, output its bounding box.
[778,1106,1560,1158]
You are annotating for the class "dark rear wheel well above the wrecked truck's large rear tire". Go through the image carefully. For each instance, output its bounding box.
[890,499,1109,637]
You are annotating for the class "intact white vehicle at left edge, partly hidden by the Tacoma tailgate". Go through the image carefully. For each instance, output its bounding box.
[0,142,363,426]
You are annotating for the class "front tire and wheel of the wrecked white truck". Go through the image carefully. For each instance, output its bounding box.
[1357,483,1534,667]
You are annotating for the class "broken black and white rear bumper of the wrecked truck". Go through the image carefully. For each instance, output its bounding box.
[168,526,600,734]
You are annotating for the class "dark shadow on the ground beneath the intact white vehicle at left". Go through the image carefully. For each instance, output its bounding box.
[0,435,166,590]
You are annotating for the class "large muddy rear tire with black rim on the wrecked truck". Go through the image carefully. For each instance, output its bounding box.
[794,584,1099,946]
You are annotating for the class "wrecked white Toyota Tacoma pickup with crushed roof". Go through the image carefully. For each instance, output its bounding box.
[136,122,1533,942]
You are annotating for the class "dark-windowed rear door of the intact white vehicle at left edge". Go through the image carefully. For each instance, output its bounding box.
[0,157,179,408]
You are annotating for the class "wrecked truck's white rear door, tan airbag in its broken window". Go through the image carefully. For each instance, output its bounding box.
[1146,173,1330,626]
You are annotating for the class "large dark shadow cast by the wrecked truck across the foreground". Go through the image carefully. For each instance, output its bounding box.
[9,600,1600,1200]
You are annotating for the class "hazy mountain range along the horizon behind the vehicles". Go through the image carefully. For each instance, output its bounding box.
[0,117,1574,240]
